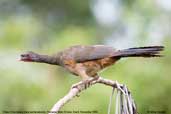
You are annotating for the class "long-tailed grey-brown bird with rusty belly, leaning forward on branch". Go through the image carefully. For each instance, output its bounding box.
[20,45,164,86]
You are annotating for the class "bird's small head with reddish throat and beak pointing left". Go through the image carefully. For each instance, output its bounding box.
[20,51,40,62]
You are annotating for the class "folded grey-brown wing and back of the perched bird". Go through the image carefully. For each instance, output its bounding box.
[65,45,115,62]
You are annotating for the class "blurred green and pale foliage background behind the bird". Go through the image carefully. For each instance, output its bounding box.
[0,0,171,114]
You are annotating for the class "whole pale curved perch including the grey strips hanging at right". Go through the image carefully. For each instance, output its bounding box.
[49,77,137,114]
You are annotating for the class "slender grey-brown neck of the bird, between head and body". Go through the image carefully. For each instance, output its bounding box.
[35,55,59,65]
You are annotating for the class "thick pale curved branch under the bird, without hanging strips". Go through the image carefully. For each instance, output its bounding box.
[49,77,136,114]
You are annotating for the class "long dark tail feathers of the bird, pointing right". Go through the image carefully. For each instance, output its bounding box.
[113,46,164,58]
